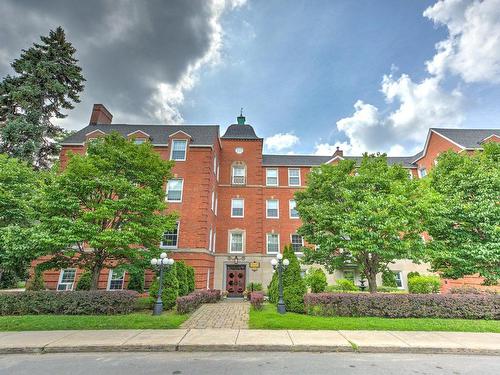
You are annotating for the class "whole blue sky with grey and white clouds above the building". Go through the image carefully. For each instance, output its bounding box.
[0,0,500,155]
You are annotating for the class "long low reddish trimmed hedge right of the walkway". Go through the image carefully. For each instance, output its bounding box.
[304,293,500,320]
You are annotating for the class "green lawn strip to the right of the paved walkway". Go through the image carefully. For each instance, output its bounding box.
[250,304,500,333]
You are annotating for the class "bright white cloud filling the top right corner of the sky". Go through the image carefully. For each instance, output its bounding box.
[424,0,500,83]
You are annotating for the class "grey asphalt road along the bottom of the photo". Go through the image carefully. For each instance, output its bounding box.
[0,352,500,375]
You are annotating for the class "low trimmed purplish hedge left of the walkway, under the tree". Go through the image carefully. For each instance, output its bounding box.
[0,291,137,315]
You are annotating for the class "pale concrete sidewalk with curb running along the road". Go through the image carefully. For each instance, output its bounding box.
[0,329,500,355]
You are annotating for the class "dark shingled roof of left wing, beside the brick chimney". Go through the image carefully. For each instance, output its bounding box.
[62,124,219,145]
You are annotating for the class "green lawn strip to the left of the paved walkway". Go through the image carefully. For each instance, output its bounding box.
[0,311,189,331]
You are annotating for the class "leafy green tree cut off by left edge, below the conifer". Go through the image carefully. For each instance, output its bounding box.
[0,154,41,283]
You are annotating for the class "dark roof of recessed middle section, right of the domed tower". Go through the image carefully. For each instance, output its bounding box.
[262,155,415,168]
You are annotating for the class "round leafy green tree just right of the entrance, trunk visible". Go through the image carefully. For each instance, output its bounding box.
[295,154,424,293]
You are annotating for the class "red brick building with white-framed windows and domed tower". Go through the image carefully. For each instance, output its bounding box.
[41,104,500,295]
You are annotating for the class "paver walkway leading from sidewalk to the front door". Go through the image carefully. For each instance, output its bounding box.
[181,300,250,329]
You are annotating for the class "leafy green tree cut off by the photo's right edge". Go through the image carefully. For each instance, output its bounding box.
[422,143,500,284]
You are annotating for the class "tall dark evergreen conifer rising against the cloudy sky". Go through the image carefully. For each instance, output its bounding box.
[0,27,85,168]
